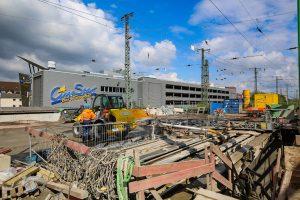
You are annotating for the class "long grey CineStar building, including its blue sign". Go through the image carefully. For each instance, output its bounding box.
[32,69,236,107]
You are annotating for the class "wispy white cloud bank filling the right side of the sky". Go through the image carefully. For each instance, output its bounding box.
[189,0,297,92]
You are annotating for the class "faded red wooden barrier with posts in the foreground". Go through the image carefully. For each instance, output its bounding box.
[129,144,236,200]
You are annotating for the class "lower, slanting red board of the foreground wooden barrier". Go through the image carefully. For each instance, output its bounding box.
[129,163,215,193]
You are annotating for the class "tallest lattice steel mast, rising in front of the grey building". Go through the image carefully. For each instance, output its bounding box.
[121,12,133,108]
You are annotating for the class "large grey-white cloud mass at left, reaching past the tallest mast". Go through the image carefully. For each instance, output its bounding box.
[0,0,176,80]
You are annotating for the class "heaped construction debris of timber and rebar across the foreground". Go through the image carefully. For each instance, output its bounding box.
[0,104,299,200]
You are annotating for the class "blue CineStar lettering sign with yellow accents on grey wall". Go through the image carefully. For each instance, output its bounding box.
[50,84,97,105]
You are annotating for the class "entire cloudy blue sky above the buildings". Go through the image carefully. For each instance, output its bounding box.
[0,0,298,96]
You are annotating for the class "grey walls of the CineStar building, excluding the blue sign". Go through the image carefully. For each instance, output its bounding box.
[32,70,236,107]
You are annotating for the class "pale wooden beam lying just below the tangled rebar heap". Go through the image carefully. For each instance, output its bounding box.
[46,181,89,199]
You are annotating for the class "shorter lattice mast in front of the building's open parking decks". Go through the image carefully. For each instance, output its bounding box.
[201,48,210,107]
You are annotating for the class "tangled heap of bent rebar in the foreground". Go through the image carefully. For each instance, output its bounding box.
[45,134,119,200]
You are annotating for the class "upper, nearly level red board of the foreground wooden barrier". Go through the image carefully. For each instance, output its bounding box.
[132,160,205,177]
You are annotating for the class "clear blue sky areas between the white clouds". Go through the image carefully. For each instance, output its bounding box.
[81,0,297,90]
